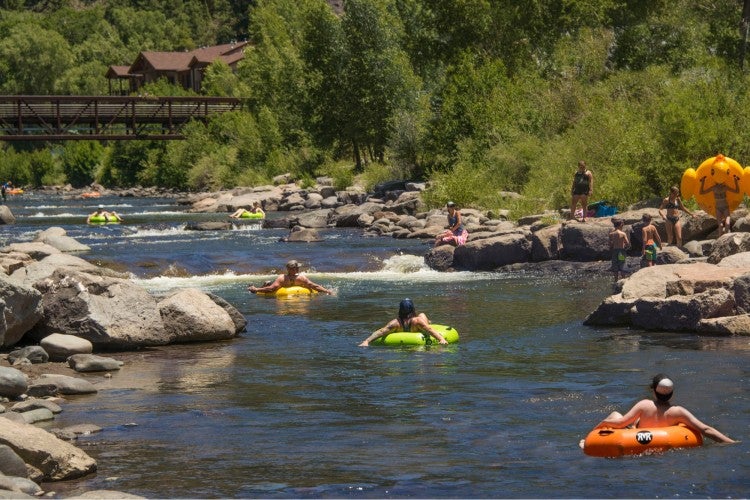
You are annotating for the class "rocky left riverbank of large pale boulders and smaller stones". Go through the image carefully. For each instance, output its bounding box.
[0,228,247,498]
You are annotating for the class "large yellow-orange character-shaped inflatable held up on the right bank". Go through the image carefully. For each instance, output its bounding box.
[680,154,750,216]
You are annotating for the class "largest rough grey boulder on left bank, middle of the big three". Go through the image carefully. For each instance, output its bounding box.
[32,270,169,351]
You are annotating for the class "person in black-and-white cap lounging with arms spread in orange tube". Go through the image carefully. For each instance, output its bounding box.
[595,373,737,443]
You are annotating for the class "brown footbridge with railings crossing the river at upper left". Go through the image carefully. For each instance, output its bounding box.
[0,95,241,141]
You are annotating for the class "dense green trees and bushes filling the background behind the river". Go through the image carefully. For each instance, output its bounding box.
[0,0,750,215]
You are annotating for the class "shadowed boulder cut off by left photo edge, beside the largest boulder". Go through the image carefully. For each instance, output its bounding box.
[0,274,42,346]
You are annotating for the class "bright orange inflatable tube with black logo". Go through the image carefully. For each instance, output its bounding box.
[583,424,703,457]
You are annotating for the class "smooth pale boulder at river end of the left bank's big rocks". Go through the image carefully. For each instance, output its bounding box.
[158,288,236,342]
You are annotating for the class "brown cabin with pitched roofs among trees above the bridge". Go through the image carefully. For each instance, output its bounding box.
[105,42,248,95]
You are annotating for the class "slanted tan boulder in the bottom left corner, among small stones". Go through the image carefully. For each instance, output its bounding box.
[0,420,96,481]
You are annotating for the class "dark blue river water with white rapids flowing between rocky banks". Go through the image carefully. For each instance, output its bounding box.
[0,194,750,498]
